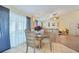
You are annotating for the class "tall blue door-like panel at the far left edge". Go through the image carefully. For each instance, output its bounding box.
[0,6,10,52]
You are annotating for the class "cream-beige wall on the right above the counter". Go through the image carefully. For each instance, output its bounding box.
[59,10,79,35]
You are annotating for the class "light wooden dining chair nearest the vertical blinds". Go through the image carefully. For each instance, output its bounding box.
[25,30,37,53]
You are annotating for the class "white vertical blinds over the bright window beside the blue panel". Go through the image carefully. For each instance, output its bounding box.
[9,11,27,47]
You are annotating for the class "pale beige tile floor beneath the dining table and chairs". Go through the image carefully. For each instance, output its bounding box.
[3,43,77,53]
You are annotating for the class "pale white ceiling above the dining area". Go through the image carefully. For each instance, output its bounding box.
[6,5,79,16]
